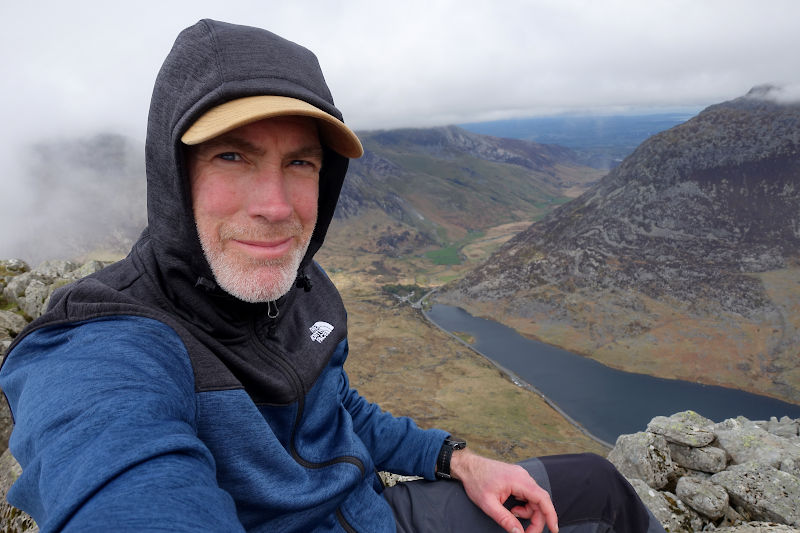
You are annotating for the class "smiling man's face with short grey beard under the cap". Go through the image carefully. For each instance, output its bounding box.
[188,116,322,302]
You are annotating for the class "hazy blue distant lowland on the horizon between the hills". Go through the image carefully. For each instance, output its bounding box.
[460,111,696,169]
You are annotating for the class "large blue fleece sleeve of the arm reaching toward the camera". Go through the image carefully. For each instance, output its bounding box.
[0,317,243,532]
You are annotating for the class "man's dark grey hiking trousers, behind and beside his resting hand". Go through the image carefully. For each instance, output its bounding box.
[384,453,664,533]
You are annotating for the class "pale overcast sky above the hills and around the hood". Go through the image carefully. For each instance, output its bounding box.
[0,0,800,262]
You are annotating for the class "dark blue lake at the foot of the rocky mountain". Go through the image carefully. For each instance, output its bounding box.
[428,304,800,444]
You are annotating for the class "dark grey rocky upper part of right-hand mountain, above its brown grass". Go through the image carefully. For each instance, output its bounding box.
[444,85,800,314]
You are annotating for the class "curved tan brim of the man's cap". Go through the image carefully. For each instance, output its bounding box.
[181,95,364,158]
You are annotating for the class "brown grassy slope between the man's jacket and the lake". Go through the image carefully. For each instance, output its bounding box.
[333,273,607,461]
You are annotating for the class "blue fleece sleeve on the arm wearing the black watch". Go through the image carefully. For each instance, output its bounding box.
[340,370,448,479]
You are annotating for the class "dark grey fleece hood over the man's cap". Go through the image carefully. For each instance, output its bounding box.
[143,20,349,300]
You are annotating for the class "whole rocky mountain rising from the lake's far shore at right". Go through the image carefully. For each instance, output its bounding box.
[443,87,800,403]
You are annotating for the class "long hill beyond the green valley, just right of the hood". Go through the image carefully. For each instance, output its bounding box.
[336,127,605,255]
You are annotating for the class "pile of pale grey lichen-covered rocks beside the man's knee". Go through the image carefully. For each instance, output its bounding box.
[608,411,800,533]
